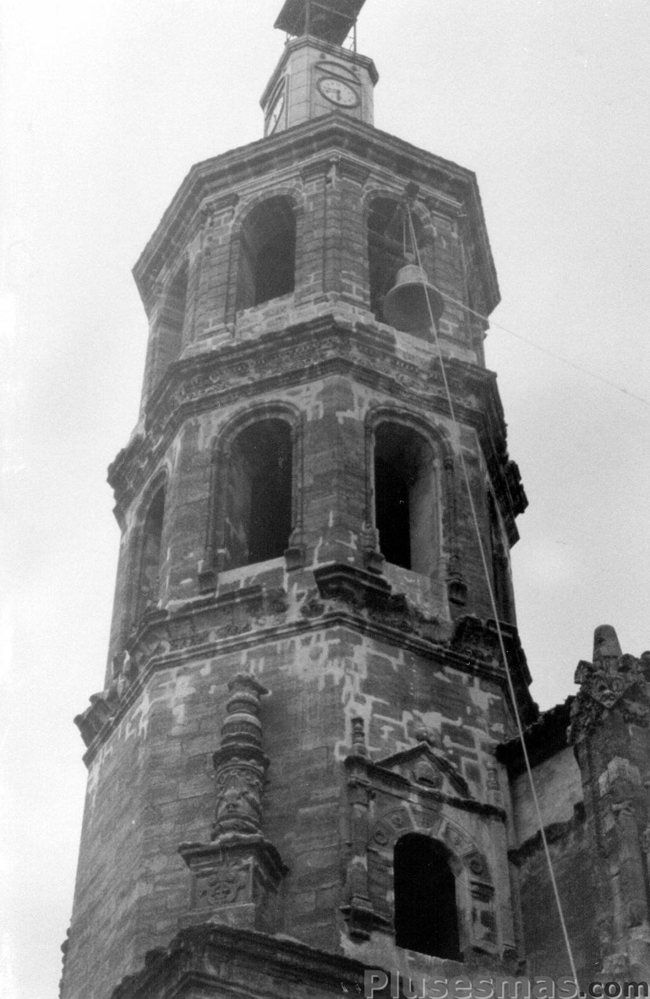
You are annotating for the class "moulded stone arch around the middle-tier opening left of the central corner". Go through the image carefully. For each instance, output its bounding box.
[203,401,303,579]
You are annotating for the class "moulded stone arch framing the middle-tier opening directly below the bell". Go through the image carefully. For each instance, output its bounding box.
[364,405,456,576]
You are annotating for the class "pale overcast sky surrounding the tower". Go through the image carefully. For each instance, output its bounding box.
[0,0,650,999]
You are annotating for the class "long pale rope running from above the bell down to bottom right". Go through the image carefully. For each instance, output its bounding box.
[406,202,579,988]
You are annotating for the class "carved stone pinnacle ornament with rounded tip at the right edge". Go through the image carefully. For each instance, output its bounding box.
[569,625,650,743]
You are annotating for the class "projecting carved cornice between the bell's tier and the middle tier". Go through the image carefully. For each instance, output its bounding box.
[108,314,525,537]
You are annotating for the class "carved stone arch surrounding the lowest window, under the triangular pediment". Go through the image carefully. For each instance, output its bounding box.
[367,802,499,956]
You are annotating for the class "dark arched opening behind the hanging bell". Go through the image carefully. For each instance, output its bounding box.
[368,198,430,322]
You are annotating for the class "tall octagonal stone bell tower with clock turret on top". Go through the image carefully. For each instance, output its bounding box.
[62,0,644,999]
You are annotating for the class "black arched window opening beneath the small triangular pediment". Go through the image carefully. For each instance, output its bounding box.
[394,833,462,961]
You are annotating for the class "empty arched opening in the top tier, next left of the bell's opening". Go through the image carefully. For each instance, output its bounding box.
[237,197,296,309]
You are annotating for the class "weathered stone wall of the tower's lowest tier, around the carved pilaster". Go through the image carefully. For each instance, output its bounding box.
[64,560,512,999]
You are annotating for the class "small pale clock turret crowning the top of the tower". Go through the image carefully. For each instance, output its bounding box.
[261,0,378,136]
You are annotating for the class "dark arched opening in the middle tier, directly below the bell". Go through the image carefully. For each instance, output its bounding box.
[374,422,438,574]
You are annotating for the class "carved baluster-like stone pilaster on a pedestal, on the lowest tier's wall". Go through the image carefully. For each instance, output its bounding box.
[179,673,287,931]
